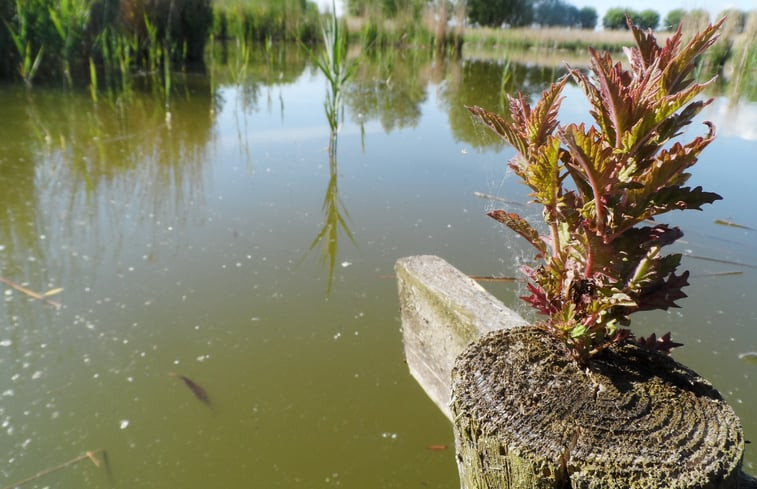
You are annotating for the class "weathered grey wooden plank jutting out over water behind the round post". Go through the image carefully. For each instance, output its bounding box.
[394,256,526,420]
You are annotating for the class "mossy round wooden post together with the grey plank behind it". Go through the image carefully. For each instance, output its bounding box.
[395,256,757,489]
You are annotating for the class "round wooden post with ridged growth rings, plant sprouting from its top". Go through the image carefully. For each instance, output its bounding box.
[452,327,744,489]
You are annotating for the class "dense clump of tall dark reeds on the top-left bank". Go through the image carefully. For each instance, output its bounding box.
[0,0,212,86]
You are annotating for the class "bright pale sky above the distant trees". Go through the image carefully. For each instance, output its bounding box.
[316,0,757,24]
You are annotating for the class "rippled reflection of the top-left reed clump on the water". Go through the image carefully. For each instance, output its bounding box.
[0,86,211,315]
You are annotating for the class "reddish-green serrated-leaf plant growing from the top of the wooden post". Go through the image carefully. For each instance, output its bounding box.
[468,20,722,361]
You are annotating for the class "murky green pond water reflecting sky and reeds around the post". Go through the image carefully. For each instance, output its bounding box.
[0,44,757,488]
